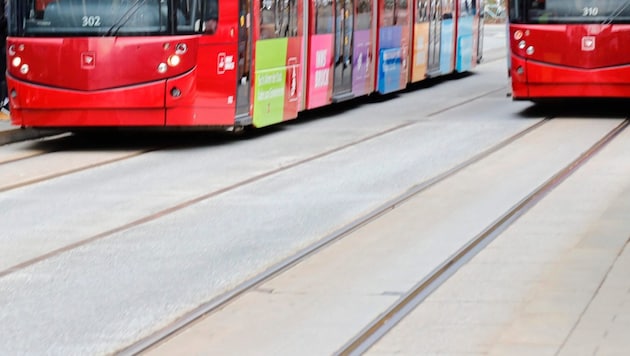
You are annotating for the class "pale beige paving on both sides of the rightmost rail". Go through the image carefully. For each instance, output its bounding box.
[149,119,630,355]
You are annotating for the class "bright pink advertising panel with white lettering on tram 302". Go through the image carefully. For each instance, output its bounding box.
[306,34,334,109]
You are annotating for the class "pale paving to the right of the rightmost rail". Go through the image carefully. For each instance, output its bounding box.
[368,127,630,356]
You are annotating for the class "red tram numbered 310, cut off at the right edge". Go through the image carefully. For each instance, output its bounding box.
[508,0,630,100]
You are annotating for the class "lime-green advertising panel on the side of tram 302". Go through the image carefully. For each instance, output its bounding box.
[254,38,288,127]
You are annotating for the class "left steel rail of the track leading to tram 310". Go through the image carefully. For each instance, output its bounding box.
[117,119,549,355]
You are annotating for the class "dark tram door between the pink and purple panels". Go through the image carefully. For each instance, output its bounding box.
[333,0,354,101]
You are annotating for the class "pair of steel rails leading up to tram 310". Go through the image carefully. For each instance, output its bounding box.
[130,118,630,355]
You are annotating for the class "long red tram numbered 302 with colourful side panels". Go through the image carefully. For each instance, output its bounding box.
[7,0,483,129]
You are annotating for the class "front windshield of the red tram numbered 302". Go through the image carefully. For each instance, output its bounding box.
[8,0,216,37]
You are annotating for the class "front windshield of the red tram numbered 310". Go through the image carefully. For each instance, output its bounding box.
[508,0,630,24]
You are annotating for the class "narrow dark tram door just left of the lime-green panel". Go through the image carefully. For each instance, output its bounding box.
[236,0,252,118]
